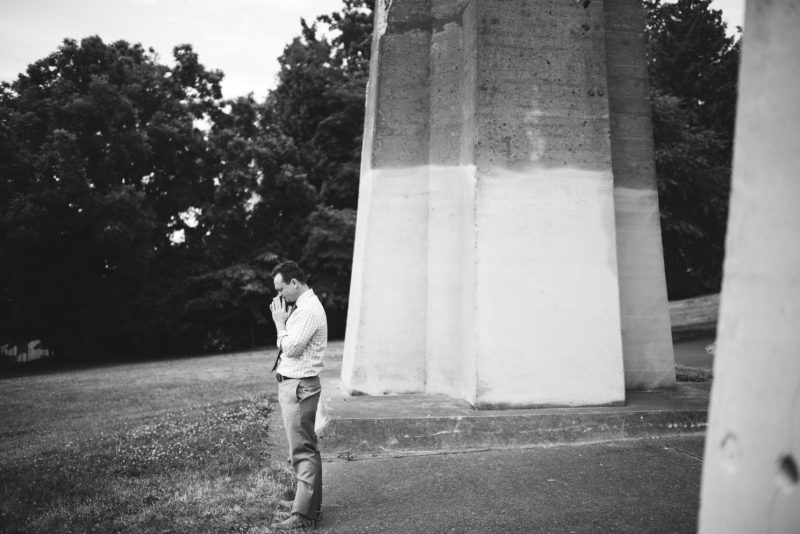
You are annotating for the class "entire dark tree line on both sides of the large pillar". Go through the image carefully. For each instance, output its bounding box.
[0,0,739,360]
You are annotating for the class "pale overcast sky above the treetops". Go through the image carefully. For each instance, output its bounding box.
[0,0,744,99]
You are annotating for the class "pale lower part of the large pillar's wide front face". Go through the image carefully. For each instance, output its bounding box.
[467,168,625,407]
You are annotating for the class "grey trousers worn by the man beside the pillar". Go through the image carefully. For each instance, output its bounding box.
[278,376,322,519]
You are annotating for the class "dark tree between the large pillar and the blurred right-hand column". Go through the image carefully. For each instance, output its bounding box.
[645,0,741,299]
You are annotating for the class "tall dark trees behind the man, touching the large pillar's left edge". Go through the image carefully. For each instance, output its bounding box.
[177,0,373,348]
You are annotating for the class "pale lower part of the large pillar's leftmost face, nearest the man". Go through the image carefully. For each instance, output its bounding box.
[342,167,428,395]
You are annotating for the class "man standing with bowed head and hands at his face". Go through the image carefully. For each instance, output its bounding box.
[270,261,328,530]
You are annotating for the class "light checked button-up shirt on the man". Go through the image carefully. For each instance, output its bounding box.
[276,289,328,378]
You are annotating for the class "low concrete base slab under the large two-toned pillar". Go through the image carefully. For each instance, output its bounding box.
[318,357,709,458]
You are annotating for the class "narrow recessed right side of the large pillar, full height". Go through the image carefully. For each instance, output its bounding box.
[603,0,675,389]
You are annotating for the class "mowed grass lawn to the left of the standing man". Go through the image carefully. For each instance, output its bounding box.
[0,343,350,533]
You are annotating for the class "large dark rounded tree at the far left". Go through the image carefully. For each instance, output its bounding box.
[0,37,222,357]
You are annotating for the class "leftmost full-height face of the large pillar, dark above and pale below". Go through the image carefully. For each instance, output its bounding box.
[342,0,431,395]
